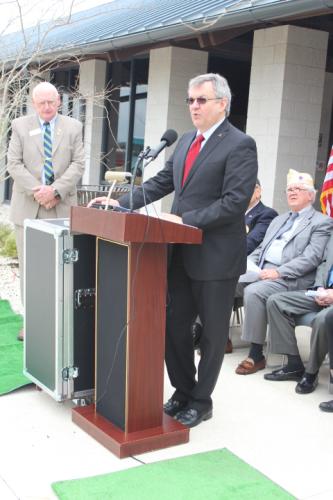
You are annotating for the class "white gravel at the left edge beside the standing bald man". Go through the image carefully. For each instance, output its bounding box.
[0,204,23,314]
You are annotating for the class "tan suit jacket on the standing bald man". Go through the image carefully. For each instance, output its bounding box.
[7,115,84,225]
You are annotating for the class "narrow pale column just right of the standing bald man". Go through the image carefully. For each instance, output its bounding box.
[79,59,107,184]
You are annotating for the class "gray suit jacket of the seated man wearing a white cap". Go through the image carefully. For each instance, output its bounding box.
[250,207,333,290]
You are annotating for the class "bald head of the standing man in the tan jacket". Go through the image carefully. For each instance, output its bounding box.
[32,82,60,122]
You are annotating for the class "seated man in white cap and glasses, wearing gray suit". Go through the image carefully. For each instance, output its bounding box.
[236,170,333,375]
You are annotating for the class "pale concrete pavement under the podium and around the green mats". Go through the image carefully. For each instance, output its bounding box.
[0,331,333,500]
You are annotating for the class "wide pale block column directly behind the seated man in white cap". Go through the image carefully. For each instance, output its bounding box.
[247,26,328,212]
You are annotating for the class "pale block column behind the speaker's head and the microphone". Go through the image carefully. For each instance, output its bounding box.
[145,47,208,211]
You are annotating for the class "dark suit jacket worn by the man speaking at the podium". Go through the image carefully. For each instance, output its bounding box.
[119,119,258,280]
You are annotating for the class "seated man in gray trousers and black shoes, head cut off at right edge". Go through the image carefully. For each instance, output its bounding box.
[264,232,333,394]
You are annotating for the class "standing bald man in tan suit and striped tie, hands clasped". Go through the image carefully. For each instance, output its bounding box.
[7,82,84,337]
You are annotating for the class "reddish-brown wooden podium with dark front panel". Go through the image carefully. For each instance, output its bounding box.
[71,207,202,458]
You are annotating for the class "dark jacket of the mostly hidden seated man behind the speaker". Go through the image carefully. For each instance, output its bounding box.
[245,201,278,255]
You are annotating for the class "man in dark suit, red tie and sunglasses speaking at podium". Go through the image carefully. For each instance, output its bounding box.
[93,73,257,427]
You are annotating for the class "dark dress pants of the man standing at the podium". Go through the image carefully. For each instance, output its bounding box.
[165,246,237,410]
